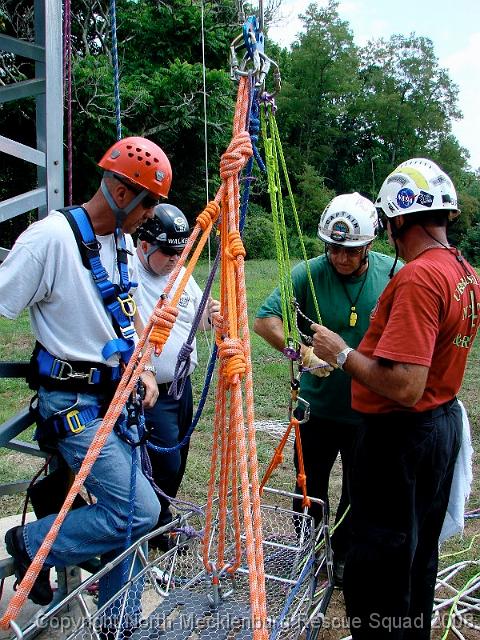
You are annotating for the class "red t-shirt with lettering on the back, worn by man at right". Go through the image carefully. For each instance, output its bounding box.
[352,248,480,413]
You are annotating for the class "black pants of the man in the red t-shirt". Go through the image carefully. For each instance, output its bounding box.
[344,400,462,640]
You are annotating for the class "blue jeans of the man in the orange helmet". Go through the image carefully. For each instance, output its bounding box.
[24,388,160,613]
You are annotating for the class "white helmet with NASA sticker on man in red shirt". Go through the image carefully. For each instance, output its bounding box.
[376,158,459,218]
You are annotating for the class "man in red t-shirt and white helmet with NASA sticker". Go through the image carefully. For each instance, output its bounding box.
[312,158,480,640]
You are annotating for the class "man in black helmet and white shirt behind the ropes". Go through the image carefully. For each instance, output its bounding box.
[135,204,220,550]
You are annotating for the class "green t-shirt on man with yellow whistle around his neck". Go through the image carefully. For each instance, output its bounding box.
[257,251,402,423]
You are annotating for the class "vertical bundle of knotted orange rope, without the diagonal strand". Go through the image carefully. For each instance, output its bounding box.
[199,78,268,640]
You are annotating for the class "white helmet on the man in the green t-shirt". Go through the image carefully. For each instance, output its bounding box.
[318,193,378,247]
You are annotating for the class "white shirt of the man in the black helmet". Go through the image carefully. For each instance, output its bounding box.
[134,253,202,383]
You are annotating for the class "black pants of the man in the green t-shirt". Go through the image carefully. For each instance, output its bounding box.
[293,415,357,561]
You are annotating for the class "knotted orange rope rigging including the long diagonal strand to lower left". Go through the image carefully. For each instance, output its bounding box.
[0,78,268,640]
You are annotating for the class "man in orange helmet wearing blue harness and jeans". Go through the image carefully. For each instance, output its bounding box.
[0,138,172,636]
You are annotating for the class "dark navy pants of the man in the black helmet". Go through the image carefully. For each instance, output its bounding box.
[145,378,193,527]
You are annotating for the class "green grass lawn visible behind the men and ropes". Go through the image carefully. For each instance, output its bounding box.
[0,260,480,640]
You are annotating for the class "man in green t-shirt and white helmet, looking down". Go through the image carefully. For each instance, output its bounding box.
[254,193,400,586]
